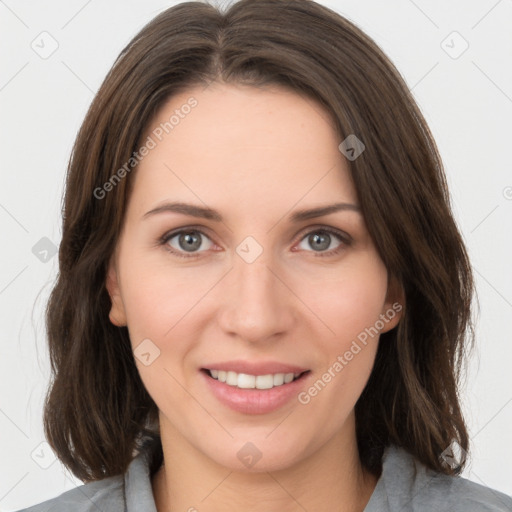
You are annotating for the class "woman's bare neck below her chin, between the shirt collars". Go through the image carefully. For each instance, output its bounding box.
[152,412,377,512]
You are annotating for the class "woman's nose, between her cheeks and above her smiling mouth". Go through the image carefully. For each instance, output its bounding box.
[217,247,299,343]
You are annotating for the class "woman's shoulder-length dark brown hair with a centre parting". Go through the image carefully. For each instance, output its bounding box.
[44,0,474,481]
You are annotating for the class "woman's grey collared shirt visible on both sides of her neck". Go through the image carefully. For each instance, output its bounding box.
[19,446,512,512]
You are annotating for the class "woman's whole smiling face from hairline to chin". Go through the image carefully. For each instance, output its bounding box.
[107,83,401,470]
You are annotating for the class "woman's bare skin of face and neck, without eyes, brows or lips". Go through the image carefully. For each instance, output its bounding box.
[107,83,402,512]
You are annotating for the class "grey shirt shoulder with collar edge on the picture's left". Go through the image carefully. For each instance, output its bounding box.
[13,455,154,512]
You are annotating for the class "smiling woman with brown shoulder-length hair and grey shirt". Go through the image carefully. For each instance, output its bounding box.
[16,0,512,512]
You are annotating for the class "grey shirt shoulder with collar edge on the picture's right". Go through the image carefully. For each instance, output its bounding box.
[365,446,512,512]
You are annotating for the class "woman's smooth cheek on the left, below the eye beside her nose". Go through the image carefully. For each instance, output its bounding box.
[121,255,207,400]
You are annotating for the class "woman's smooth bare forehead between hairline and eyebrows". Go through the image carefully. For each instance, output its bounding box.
[130,83,356,218]
